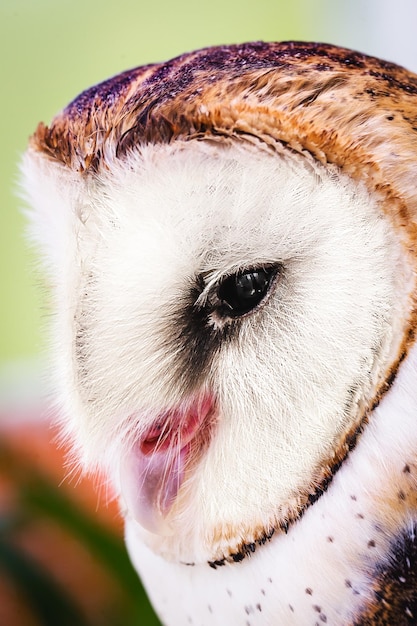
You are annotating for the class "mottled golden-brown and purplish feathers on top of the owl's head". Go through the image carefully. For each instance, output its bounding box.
[31,42,417,236]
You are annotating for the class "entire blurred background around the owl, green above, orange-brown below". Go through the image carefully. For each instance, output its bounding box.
[0,0,417,626]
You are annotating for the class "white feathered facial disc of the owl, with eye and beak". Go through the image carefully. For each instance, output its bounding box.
[24,135,411,561]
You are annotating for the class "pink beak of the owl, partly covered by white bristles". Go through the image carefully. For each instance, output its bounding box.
[121,394,215,535]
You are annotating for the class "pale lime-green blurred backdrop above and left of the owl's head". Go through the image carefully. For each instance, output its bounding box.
[0,0,417,380]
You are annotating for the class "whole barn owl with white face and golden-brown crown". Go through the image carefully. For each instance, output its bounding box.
[22,42,417,626]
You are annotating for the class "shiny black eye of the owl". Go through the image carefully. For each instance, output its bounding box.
[217,267,277,317]
